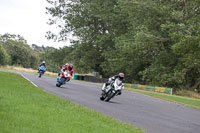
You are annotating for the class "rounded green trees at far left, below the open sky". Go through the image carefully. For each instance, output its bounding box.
[0,34,40,68]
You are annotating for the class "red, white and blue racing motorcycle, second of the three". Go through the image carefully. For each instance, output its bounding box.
[56,71,71,87]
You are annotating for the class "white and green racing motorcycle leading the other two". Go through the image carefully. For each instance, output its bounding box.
[100,78,124,102]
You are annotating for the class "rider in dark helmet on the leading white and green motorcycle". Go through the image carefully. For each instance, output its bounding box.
[101,73,125,96]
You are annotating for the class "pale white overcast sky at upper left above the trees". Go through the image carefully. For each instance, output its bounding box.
[0,0,69,48]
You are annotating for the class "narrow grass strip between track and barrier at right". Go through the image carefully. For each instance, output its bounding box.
[126,88,200,109]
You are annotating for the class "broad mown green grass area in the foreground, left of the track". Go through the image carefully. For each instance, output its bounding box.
[0,72,143,133]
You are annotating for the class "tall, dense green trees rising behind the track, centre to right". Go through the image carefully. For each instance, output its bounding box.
[0,0,200,91]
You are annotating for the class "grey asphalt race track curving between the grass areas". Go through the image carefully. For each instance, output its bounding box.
[14,73,200,133]
